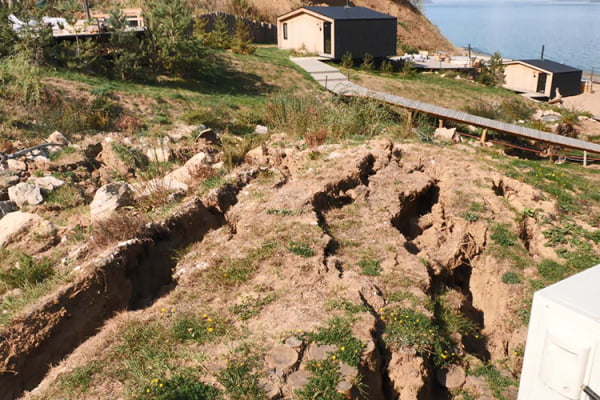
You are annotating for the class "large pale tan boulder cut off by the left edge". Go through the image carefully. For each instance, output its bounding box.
[0,211,56,248]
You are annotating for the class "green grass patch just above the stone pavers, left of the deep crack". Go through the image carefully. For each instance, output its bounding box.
[302,317,364,367]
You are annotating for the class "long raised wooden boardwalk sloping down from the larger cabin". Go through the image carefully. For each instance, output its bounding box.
[292,59,600,154]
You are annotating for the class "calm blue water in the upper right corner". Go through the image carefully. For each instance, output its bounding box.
[424,2,600,71]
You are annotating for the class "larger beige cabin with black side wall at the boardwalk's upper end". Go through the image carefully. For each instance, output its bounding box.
[277,6,398,59]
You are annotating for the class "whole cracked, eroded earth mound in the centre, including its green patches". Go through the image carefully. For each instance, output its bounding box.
[10,136,597,399]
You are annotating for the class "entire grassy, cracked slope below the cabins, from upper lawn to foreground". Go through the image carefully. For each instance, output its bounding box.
[0,25,600,400]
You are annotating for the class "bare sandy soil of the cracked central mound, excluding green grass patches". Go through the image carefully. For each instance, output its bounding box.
[9,132,593,399]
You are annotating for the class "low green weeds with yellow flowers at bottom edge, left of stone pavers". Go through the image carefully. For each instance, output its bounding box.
[136,371,223,400]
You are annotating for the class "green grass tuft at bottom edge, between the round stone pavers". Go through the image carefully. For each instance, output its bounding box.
[296,359,344,400]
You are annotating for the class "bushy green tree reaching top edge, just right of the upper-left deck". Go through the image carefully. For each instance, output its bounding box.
[144,0,203,75]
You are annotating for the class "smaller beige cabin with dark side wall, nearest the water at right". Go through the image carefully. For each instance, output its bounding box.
[504,60,582,98]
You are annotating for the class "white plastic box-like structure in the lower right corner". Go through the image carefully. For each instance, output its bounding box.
[518,265,600,400]
